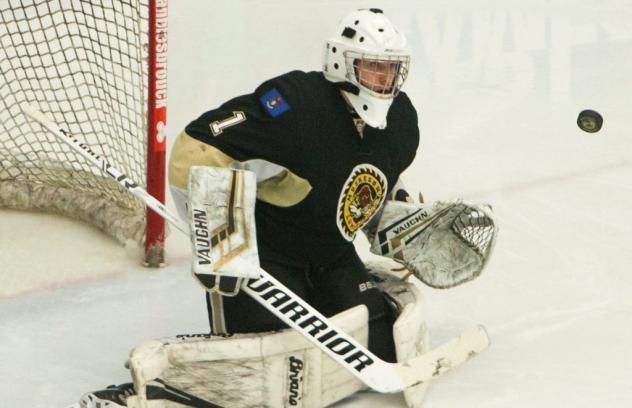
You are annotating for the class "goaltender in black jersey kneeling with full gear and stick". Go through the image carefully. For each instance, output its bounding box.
[68,9,497,408]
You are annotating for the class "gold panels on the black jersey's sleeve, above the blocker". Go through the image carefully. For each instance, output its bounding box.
[169,132,312,207]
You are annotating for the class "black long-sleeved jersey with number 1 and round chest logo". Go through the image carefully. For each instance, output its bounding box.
[170,71,419,265]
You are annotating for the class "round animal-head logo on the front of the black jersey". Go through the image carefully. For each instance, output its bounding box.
[336,164,388,241]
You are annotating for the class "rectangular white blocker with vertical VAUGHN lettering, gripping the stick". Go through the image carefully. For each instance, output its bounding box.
[187,166,259,296]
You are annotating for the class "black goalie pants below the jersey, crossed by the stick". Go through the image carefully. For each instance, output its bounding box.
[206,250,397,362]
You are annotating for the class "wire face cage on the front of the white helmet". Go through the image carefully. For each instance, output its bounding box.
[344,50,410,99]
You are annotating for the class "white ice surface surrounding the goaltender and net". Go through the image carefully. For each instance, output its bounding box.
[0,0,632,408]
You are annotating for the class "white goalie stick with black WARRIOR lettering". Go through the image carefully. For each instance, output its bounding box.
[22,105,489,393]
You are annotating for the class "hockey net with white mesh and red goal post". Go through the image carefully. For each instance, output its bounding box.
[0,0,167,266]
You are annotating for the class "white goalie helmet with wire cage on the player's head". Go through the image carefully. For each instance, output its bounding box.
[323,9,410,129]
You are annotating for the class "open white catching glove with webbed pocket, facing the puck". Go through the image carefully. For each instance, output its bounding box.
[371,201,498,289]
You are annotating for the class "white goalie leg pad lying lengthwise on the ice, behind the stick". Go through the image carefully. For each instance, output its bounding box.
[127,305,368,408]
